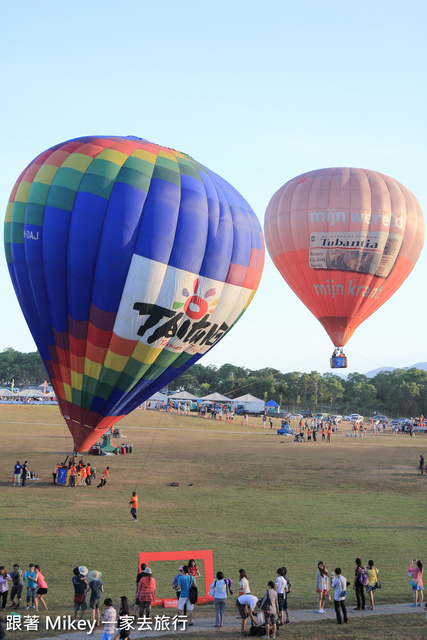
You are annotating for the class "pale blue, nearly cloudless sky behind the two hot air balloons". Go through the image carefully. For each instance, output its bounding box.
[0,0,427,373]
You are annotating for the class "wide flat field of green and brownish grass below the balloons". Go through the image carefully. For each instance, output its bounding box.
[0,405,427,640]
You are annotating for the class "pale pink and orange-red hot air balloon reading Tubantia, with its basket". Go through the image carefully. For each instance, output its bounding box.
[264,168,424,366]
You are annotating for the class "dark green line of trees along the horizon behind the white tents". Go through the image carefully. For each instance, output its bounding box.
[0,348,427,417]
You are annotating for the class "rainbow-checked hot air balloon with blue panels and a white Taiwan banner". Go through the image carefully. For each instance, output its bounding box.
[5,137,264,451]
